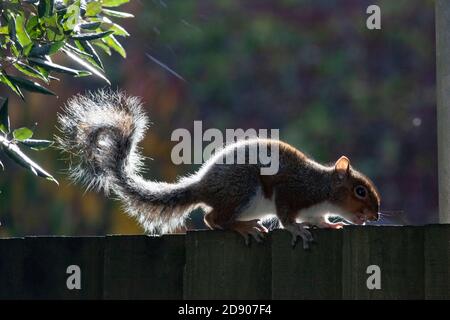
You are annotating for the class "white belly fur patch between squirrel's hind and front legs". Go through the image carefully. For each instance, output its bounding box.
[237,188,276,221]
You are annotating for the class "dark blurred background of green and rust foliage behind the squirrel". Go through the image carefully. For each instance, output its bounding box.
[0,0,437,236]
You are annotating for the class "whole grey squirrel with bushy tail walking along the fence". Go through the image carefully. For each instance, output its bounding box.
[56,90,380,248]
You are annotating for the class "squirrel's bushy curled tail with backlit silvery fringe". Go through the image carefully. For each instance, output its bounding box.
[56,90,197,233]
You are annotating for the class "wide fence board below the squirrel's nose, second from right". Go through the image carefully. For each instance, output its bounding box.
[342,226,424,299]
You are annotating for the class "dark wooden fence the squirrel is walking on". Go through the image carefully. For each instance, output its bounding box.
[0,225,450,299]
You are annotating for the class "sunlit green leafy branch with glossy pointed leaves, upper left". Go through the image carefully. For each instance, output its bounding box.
[0,0,133,182]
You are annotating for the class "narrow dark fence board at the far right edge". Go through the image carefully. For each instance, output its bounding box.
[425,224,450,300]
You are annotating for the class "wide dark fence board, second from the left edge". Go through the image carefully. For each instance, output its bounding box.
[23,237,104,299]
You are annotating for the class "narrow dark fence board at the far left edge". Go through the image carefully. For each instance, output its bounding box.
[0,238,25,300]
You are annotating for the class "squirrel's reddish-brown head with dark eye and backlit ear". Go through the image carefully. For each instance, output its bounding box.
[331,156,380,224]
